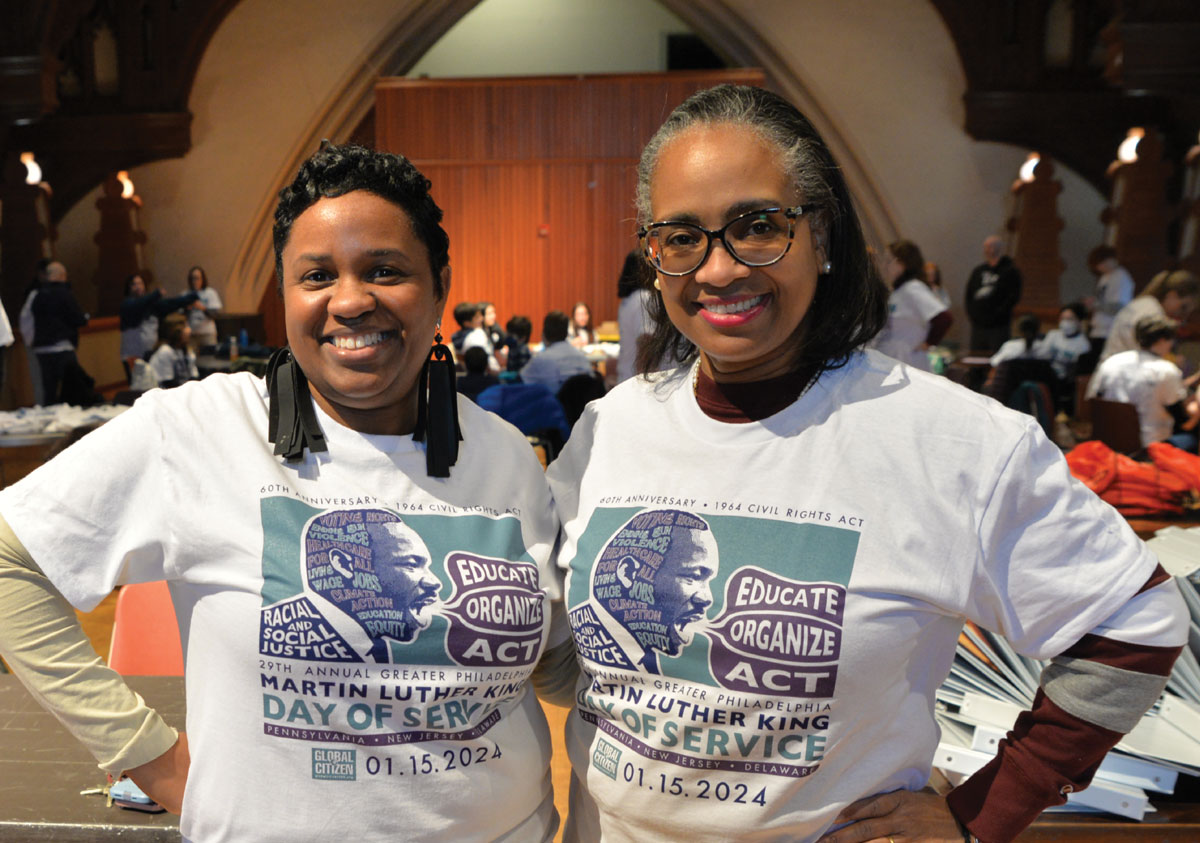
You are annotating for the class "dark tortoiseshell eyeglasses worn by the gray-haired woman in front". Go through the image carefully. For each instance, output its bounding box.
[637,205,805,275]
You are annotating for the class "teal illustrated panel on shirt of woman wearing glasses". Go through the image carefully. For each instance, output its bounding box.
[568,507,858,696]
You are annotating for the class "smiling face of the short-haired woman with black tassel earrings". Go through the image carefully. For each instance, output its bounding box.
[282,190,450,434]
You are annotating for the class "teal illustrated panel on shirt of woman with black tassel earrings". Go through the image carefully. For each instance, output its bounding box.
[259,496,544,666]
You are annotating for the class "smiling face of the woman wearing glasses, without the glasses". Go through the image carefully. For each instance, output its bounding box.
[650,124,824,381]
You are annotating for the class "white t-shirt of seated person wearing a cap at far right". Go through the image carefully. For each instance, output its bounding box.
[1087,348,1187,446]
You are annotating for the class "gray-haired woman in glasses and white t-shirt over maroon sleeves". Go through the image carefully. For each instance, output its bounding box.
[548,85,1187,843]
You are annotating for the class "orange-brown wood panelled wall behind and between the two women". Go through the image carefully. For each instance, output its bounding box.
[376,70,763,340]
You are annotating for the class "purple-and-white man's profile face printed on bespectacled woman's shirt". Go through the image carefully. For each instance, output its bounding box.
[654,527,716,656]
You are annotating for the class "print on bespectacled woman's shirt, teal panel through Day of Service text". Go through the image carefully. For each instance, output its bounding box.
[568,508,858,777]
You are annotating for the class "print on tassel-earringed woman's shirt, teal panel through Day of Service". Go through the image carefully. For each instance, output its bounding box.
[258,496,544,745]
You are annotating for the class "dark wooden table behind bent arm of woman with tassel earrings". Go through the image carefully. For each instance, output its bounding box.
[0,674,185,843]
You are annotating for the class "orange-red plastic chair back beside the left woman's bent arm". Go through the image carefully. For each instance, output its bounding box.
[108,581,184,676]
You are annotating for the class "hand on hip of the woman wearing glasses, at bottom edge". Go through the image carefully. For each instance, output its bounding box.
[821,790,962,843]
